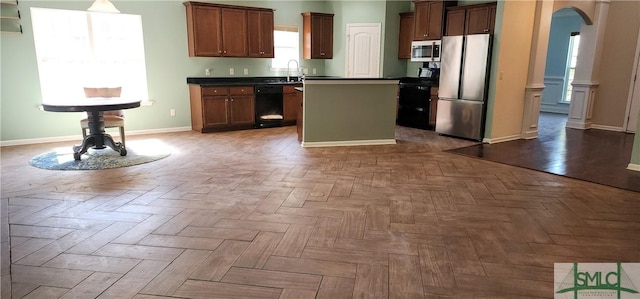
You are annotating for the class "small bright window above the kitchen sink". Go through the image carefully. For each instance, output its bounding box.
[271,25,300,70]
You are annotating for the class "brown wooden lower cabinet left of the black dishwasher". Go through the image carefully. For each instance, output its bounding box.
[189,85,255,133]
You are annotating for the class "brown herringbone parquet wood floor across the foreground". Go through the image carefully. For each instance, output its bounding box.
[0,127,640,299]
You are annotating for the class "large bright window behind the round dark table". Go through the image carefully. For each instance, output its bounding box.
[31,8,149,103]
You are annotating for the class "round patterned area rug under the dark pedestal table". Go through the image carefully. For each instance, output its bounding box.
[29,143,171,170]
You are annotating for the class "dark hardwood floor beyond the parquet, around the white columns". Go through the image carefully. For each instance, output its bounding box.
[450,113,640,192]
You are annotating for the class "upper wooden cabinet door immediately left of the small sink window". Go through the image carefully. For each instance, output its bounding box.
[247,10,274,58]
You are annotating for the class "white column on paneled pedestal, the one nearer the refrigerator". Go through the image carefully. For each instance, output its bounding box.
[520,1,553,139]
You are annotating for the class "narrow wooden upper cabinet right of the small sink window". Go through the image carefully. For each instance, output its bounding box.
[302,12,333,59]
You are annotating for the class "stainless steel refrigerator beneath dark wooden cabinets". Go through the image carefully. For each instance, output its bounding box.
[436,34,491,140]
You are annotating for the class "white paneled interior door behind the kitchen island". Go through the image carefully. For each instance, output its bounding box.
[346,23,380,78]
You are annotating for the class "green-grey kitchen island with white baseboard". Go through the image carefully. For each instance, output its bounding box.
[302,78,399,147]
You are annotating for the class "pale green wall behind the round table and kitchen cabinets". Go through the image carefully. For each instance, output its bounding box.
[0,0,410,141]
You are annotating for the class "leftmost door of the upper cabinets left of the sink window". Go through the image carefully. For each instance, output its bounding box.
[187,5,222,56]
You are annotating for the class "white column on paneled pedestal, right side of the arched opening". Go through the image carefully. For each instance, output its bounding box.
[567,0,609,130]
